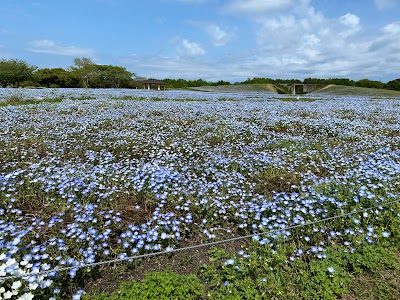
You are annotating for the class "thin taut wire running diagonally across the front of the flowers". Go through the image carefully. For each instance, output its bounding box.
[0,199,400,282]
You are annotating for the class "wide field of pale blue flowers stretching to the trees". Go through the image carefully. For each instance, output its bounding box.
[0,89,400,299]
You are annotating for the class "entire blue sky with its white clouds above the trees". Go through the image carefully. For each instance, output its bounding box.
[0,0,400,82]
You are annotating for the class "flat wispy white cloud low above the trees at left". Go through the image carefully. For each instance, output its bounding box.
[28,40,94,57]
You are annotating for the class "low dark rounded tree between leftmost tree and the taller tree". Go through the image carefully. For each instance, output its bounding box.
[33,68,80,88]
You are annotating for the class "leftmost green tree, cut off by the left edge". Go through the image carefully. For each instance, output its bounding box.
[0,59,37,87]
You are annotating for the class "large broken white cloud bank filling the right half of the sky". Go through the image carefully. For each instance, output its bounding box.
[119,0,400,81]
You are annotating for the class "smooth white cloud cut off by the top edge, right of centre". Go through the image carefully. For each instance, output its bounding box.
[226,0,293,13]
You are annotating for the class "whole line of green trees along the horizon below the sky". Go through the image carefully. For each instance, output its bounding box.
[0,57,400,91]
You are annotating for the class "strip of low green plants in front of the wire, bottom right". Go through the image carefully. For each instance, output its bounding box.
[84,233,400,300]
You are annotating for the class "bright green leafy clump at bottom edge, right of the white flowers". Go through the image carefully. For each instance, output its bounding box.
[91,270,205,300]
